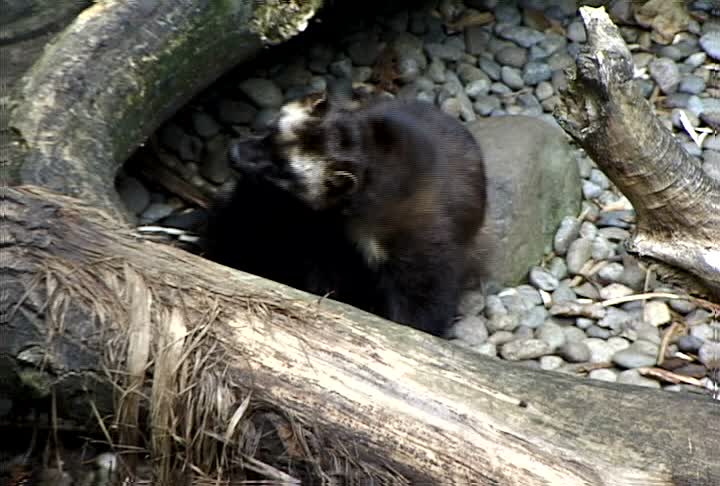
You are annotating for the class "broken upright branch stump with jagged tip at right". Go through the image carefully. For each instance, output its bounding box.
[556,7,720,299]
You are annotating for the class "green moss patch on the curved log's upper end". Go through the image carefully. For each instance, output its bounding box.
[250,0,323,44]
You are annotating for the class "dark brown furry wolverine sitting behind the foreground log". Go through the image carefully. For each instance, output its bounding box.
[202,83,485,336]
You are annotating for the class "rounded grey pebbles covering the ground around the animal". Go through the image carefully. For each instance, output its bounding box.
[118,0,720,394]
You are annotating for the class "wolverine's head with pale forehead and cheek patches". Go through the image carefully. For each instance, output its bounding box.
[230,79,388,209]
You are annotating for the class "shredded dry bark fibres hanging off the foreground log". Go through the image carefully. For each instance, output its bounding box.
[36,252,407,485]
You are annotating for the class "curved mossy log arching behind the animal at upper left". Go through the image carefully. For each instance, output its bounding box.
[9,0,322,220]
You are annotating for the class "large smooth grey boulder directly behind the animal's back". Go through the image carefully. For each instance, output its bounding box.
[468,116,581,286]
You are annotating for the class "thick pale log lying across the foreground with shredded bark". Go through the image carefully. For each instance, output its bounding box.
[0,187,720,486]
